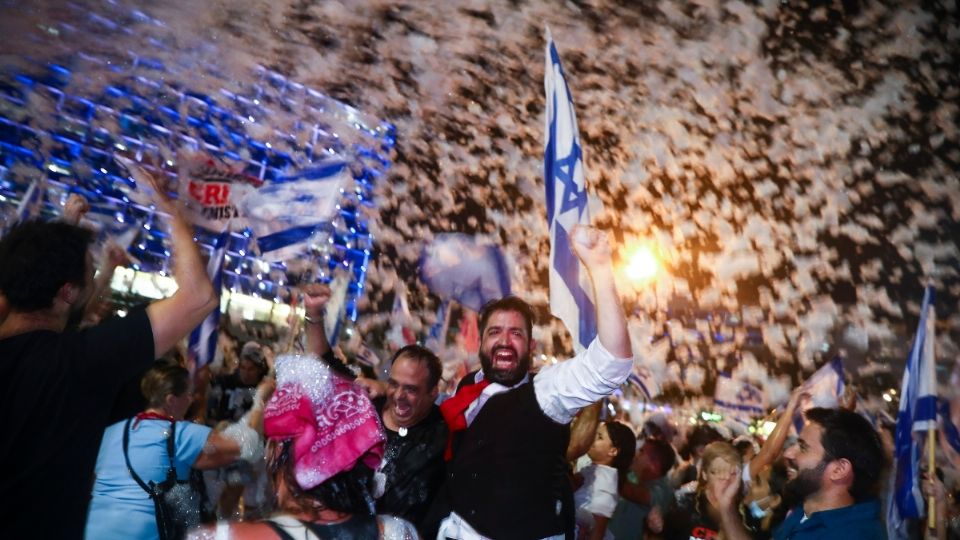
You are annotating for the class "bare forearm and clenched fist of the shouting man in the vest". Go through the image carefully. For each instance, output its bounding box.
[570,225,633,361]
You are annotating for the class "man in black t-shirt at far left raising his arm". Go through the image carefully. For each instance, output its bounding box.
[0,174,217,539]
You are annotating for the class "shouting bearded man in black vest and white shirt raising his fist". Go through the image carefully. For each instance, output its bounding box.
[438,227,633,540]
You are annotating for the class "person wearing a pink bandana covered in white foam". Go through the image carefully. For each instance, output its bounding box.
[189,355,419,540]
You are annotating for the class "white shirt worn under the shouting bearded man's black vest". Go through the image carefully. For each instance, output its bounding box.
[437,338,633,540]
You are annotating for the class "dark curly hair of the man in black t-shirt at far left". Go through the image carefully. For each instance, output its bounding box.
[0,221,93,312]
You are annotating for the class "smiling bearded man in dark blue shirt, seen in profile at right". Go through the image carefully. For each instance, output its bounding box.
[774,408,887,540]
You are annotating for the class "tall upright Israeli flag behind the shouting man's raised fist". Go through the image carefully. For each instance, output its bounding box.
[543,30,597,350]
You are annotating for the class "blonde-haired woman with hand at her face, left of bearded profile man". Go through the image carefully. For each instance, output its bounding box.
[663,441,750,540]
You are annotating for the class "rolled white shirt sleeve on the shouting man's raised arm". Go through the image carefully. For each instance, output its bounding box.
[533,338,633,424]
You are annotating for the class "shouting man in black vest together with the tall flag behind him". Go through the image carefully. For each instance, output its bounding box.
[433,29,633,540]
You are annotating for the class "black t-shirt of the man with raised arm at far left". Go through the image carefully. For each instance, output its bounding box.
[0,308,154,539]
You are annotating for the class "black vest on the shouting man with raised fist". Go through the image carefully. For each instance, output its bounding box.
[447,377,573,540]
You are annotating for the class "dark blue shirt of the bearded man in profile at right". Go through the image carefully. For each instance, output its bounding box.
[773,500,887,540]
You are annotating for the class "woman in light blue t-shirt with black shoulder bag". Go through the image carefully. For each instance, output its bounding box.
[84,362,273,540]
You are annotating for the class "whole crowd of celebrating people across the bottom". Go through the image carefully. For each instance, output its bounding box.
[0,190,960,540]
